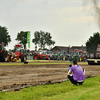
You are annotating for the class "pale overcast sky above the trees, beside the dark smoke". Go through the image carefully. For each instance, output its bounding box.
[0,0,99,50]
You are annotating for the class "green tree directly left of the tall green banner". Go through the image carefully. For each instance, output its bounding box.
[15,31,28,49]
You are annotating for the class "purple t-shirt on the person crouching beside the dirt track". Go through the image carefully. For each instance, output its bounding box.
[71,65,85,81]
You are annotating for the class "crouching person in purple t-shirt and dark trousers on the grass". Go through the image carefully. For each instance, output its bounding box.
[68,60,85,85]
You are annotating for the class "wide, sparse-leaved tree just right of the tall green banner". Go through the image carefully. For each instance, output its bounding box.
[32,31,55,49]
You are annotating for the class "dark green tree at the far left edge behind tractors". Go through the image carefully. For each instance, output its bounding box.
[0,26,11,46]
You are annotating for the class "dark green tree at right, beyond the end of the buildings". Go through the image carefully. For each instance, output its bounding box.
[86,32,100,53]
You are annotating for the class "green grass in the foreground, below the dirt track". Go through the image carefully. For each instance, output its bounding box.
[0,76,100,100]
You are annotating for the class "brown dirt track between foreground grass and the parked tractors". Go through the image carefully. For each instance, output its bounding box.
[0,64,100,91]
